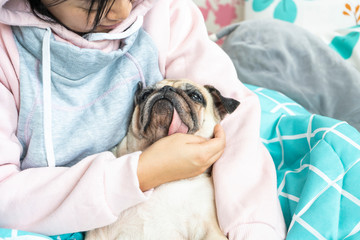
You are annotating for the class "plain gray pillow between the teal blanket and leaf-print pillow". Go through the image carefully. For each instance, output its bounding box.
[217,20,360,131]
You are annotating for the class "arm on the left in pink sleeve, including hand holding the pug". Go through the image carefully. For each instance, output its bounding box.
[0,75,225,235]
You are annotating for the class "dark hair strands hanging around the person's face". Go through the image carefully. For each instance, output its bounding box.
[27,0,115,30]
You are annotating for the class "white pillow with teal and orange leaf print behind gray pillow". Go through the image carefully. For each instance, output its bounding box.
[244,0,360,70]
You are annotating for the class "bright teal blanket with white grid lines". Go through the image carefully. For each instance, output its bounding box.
[0,85,360,240]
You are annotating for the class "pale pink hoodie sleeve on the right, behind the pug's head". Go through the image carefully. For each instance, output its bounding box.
[143,0,286,240]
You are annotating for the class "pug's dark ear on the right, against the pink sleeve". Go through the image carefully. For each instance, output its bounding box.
[204,85,240,120]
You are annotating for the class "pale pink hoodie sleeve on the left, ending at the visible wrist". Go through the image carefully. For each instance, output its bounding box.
[0,24,150,235]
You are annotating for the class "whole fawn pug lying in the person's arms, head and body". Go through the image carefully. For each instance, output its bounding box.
[85,79,240,240]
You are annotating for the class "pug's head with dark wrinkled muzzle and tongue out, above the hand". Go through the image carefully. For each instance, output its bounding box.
[116,79,240,156]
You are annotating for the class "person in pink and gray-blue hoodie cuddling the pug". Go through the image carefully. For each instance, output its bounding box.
[0,0,286,239]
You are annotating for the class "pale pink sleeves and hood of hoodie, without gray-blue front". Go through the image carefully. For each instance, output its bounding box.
[0,0,286,239]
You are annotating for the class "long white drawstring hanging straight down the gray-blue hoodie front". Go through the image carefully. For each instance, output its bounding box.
[42,28,55,167]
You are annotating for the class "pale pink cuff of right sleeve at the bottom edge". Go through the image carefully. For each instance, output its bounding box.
[228,223,285,240]
